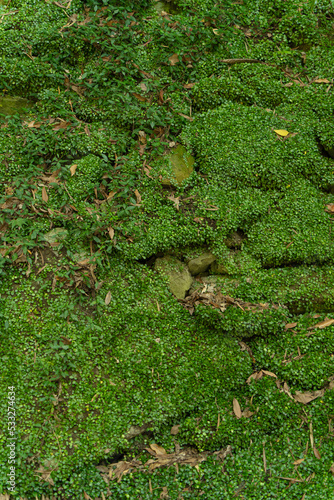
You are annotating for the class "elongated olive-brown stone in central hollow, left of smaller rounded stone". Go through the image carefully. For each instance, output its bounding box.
[154,255,192,299]
